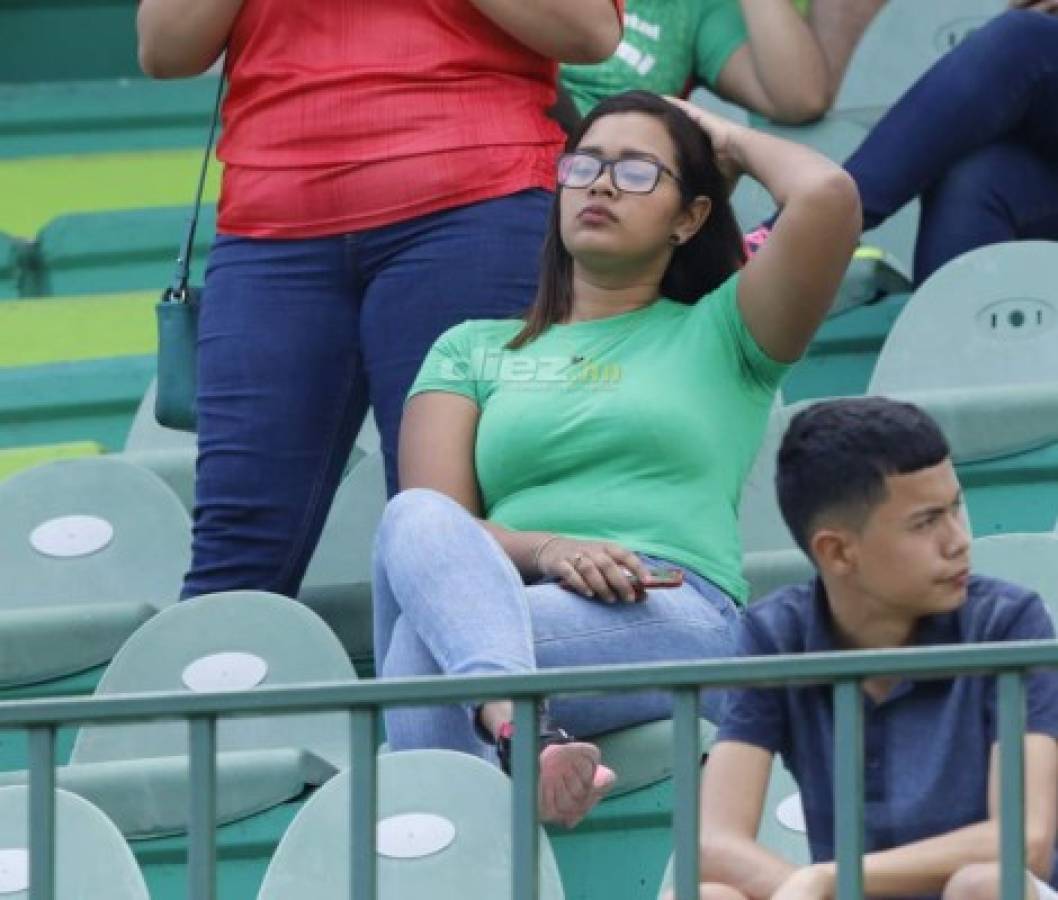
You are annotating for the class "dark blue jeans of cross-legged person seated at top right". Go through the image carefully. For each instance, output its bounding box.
[845,11,1058,283]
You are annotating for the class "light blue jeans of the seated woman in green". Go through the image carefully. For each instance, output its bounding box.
[372,489,738,757]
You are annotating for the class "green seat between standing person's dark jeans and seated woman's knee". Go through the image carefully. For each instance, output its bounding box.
[298,451,386,671]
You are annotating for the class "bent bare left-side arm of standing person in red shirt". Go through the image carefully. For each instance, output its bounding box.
[136,0,242,78]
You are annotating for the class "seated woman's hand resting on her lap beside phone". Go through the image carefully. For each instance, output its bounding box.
[539,537,650,603]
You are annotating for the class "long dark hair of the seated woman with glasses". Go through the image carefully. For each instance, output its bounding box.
[508,91,746,350]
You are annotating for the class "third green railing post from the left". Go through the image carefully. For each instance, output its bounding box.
[349,706,379,900]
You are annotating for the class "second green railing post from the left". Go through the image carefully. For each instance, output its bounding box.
[187,716,217,900]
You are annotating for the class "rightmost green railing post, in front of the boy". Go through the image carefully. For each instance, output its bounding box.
[997,672,1025,900]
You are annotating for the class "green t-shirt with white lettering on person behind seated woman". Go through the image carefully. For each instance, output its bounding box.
[559,0,747,115]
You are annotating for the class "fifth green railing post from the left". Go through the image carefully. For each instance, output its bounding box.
[672,687,701,900]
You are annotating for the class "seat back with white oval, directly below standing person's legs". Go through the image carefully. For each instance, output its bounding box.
[71,591,357,768]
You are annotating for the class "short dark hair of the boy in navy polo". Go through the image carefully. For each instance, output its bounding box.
[776,397,950,555]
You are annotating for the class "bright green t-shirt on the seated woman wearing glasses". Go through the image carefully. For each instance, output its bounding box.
[409,275,787,601]
